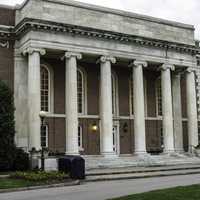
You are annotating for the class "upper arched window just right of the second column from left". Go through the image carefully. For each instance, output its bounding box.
[77,68,86,114]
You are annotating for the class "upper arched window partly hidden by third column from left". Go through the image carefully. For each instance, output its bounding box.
[112,72,118,116]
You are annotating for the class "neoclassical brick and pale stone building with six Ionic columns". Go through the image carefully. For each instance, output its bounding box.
[0,0,200,159]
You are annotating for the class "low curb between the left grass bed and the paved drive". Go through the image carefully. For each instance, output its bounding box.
[0,180,80,193]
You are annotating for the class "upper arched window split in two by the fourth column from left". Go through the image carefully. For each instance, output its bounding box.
[129,76,147,116]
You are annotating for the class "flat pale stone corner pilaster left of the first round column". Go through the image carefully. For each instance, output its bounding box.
[14,49,29,151]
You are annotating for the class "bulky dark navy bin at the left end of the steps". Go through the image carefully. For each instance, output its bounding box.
[59,156,85,179]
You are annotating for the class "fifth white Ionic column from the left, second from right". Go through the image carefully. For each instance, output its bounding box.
[161,64,174,153]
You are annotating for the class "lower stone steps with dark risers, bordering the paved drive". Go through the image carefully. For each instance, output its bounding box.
[86,165,200,182]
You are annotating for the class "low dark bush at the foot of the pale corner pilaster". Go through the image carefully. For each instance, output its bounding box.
[12,148,29,171]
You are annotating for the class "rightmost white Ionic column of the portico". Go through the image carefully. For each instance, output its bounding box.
[186,68,198,152]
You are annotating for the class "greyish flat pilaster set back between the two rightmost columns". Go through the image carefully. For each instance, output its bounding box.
[172,73,184,153]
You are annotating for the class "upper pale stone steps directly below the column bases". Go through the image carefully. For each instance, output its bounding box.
[84,154,200,172]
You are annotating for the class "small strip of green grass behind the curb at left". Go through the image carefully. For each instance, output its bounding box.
[0,178,44,189]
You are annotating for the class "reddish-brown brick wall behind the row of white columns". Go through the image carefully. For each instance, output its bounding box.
[42,59,187,155]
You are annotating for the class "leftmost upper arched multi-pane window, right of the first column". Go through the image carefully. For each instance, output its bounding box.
[40,65,50,112]
